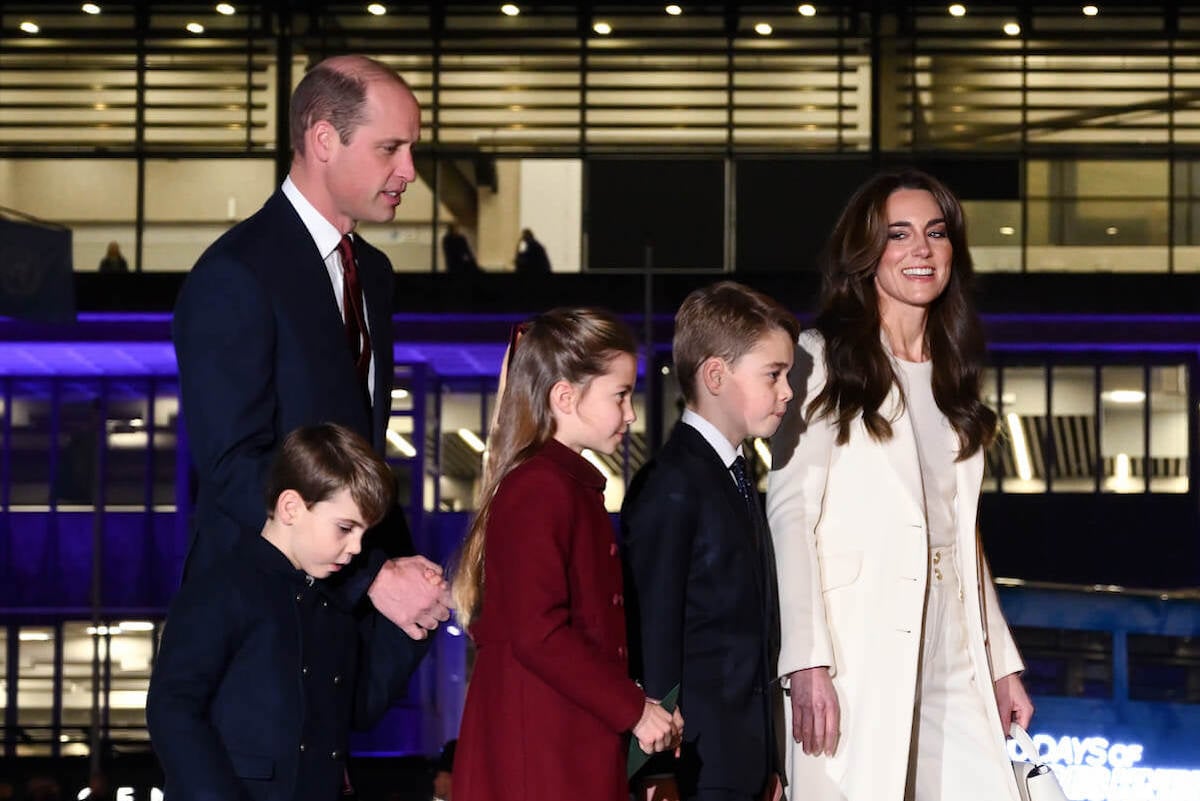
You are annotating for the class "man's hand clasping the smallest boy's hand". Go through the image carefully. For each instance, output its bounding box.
[367,556,451,639]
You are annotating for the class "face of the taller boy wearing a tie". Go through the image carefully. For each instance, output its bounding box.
[719,329,794,440]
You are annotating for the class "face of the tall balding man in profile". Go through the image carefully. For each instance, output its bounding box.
[317,78,421,233]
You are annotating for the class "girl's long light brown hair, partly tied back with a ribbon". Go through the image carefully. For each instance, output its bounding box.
[451,308,637,627]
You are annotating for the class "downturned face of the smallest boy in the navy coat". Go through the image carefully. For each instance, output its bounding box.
[268,489,367,578]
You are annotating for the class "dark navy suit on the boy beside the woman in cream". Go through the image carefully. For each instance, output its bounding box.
[620,422,779,797]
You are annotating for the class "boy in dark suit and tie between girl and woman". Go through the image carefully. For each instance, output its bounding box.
[620,282,799,801]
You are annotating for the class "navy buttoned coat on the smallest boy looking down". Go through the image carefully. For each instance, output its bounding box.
[146,536,419,801]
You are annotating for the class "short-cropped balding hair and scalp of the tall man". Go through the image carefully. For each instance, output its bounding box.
[288,55,412,157]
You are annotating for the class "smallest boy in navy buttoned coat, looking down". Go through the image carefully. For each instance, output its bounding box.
[146,424,416,801]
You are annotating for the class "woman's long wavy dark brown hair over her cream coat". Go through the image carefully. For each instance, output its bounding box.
[809,169,996,460]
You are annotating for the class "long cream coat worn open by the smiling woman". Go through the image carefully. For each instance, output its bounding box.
[767,331,1024,801]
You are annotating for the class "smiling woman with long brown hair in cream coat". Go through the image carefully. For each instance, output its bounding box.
[767,165,1033,801]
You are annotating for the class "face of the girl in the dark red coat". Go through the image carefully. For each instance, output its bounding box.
[551,354,637,453]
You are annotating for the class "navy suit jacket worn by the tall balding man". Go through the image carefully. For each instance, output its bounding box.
[173,191,412,598]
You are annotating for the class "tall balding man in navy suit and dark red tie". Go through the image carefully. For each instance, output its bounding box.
[173,56,449,648]
